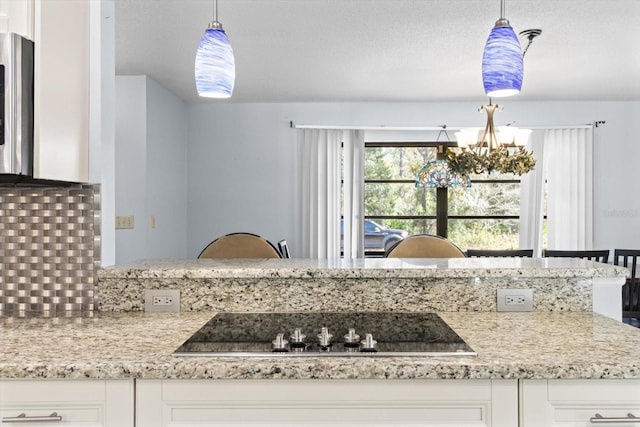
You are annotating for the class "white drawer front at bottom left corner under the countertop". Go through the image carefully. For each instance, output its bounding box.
[0,379,134,427]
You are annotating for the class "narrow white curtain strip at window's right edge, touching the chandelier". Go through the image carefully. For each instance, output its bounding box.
[520,130,545,257]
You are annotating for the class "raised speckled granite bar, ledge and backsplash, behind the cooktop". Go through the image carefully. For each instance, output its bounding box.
[97,258,627,312]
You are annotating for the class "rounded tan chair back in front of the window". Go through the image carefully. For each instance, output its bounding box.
[384,234,465,258]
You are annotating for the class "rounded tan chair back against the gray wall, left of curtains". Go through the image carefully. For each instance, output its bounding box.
[198,233,282,258]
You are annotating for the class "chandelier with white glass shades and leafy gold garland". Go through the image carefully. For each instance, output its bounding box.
[445,101,536,176]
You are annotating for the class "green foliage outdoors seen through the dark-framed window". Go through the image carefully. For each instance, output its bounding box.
[364,147,520,250]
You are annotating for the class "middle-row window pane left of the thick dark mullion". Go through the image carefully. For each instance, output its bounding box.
[364,183,436,216]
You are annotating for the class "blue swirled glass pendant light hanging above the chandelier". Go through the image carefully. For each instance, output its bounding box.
[482,0,524,98]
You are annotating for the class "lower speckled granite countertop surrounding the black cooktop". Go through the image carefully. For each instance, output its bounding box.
[0,312,640,379]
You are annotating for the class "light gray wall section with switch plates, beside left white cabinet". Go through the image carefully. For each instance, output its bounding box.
[115,76,188,264]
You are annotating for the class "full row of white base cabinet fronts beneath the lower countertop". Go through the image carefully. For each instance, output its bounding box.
[7,379,640,427]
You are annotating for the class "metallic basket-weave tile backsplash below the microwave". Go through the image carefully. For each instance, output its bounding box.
[0,185,100,313]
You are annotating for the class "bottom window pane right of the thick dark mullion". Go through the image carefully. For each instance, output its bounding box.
[449,219,520,251]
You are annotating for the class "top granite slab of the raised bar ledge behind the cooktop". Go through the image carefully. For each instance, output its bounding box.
[98,258,629,280]
